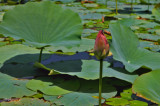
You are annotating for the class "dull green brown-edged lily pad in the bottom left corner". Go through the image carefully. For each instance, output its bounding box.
[1,98,51,106]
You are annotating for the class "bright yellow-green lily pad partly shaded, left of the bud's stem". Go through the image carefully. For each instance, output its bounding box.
[26,77,80,95]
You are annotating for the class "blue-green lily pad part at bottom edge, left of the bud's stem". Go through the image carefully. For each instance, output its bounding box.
[44,92,104,106]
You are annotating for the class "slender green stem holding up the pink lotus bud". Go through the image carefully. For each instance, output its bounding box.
[99,59,103,106]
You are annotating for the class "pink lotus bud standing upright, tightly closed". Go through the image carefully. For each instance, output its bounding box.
[94,30,109,60]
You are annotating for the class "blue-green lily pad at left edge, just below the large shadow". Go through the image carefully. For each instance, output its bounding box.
[0,73,36,98]
